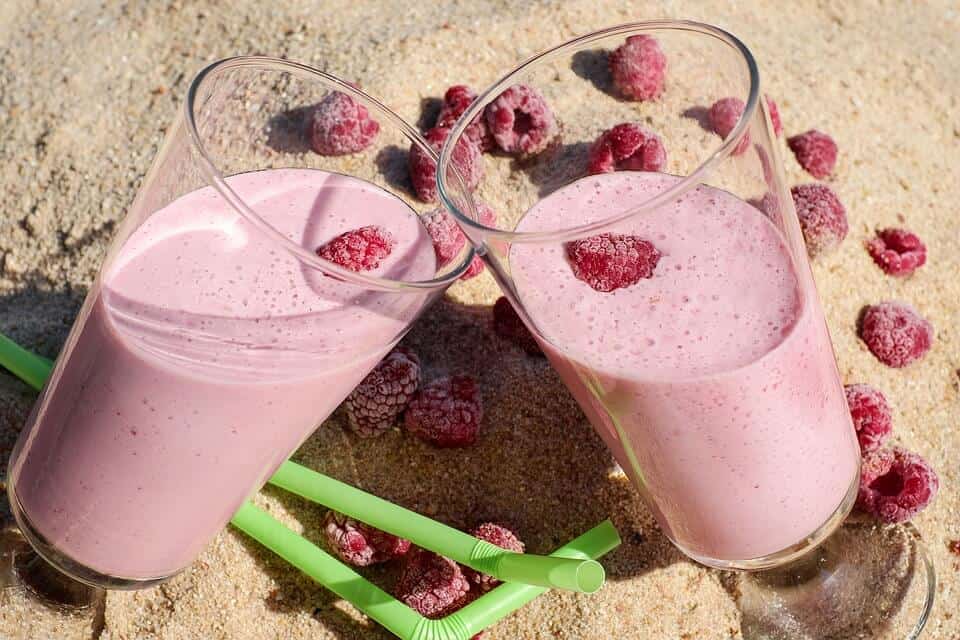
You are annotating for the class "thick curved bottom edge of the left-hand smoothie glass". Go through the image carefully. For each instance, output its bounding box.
[7,483,175,591]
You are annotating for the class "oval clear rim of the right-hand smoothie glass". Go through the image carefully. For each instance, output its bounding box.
[437,19,760,243]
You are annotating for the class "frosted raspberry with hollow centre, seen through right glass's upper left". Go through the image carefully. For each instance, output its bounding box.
[484,84,557,156]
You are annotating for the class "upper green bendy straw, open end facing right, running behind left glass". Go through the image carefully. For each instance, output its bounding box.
[0,334,616,593]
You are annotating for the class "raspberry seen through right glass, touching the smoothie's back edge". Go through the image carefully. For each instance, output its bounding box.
[589,122,667,173]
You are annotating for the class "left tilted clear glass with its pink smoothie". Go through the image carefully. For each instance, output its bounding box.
[7,58,473,608]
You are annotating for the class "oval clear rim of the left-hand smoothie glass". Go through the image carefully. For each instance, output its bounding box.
[183,56,475,292]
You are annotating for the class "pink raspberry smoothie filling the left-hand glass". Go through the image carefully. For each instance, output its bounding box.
[12,169,436,579]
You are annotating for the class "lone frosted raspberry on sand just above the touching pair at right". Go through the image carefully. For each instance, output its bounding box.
[860,302,933,369]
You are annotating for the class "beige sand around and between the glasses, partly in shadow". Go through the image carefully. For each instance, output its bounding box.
[0,0,960,640]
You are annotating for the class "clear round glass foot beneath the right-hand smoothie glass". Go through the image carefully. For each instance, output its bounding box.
[726,522,936,640]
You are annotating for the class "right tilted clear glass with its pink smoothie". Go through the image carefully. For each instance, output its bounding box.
[437,21,930,638]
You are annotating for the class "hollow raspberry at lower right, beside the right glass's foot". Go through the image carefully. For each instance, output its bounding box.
[857,447,940,523]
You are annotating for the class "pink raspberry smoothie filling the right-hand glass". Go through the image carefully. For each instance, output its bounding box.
[510,172,859,564]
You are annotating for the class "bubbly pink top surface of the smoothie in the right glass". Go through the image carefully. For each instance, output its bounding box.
[510,172,801,378]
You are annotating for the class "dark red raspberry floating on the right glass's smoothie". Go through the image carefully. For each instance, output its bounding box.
[567,233,660,292]
